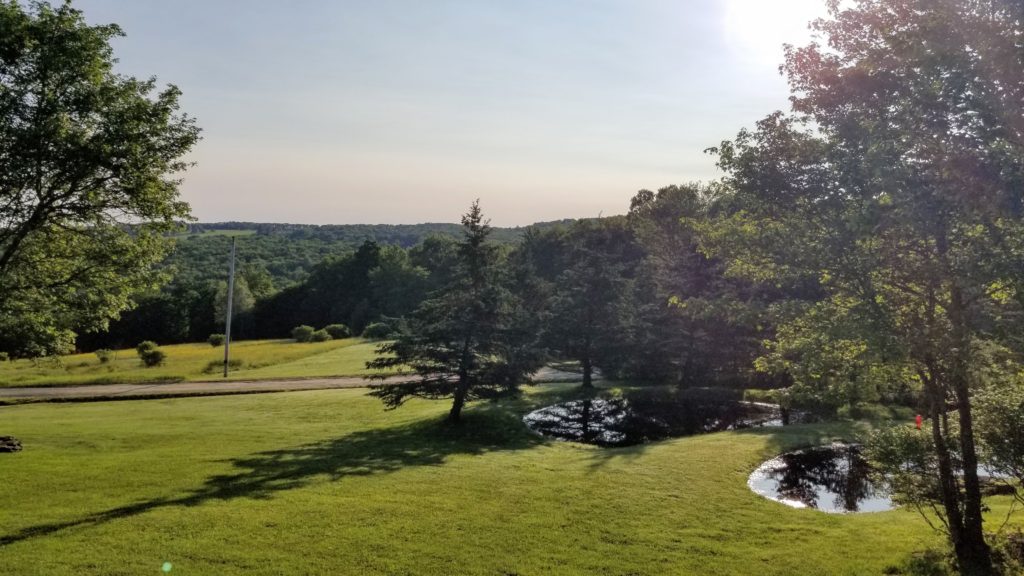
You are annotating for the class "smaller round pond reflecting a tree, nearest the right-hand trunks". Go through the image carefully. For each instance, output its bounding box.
[748,444,895,513]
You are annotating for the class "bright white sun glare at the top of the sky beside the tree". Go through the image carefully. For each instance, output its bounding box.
[724,0,826,64]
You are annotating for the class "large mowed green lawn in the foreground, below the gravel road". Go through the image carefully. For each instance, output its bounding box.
[0,384,1005,576]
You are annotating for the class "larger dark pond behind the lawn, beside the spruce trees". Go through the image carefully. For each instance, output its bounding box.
[523,394,782,446]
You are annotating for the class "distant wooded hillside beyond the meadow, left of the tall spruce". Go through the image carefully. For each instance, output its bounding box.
[77,220,571,348]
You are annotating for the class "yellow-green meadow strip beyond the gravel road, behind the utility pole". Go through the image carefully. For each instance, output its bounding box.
[0,338,385,387]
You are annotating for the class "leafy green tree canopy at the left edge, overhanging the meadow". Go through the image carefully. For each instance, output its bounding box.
[0,1,199,356]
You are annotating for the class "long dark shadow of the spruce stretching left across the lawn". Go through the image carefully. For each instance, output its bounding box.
[0,405,544,546]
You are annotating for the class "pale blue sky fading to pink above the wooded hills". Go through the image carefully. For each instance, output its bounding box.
[74,0,824,225]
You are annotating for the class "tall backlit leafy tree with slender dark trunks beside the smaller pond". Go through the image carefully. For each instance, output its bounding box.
[702,0,1024,574]
